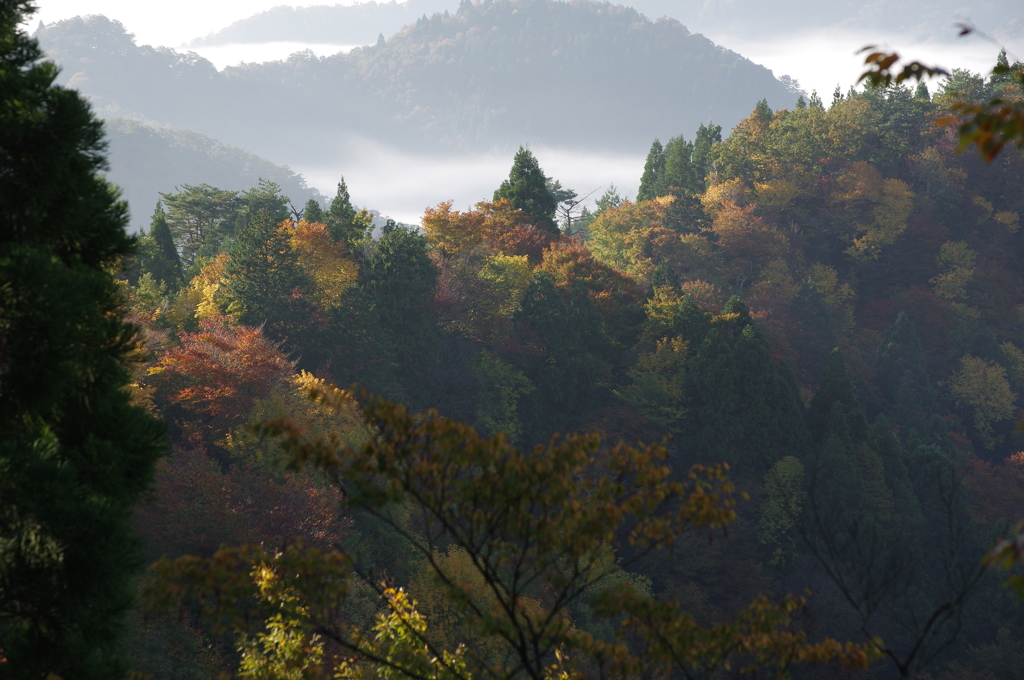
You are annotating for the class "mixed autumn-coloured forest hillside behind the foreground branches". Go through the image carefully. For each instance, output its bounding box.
[97,51,1024,680]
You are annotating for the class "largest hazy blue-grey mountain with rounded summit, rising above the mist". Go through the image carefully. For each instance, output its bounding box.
[39,0,797,162]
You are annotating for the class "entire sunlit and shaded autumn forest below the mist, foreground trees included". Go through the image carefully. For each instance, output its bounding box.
[6,2,1024,680]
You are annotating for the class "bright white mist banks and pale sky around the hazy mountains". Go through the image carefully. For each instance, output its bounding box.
[29,0,1024,224]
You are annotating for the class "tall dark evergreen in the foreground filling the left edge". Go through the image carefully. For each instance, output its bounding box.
[0,1,163,680]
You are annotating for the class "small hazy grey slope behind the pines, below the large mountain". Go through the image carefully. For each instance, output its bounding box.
[103,118,321,229]
